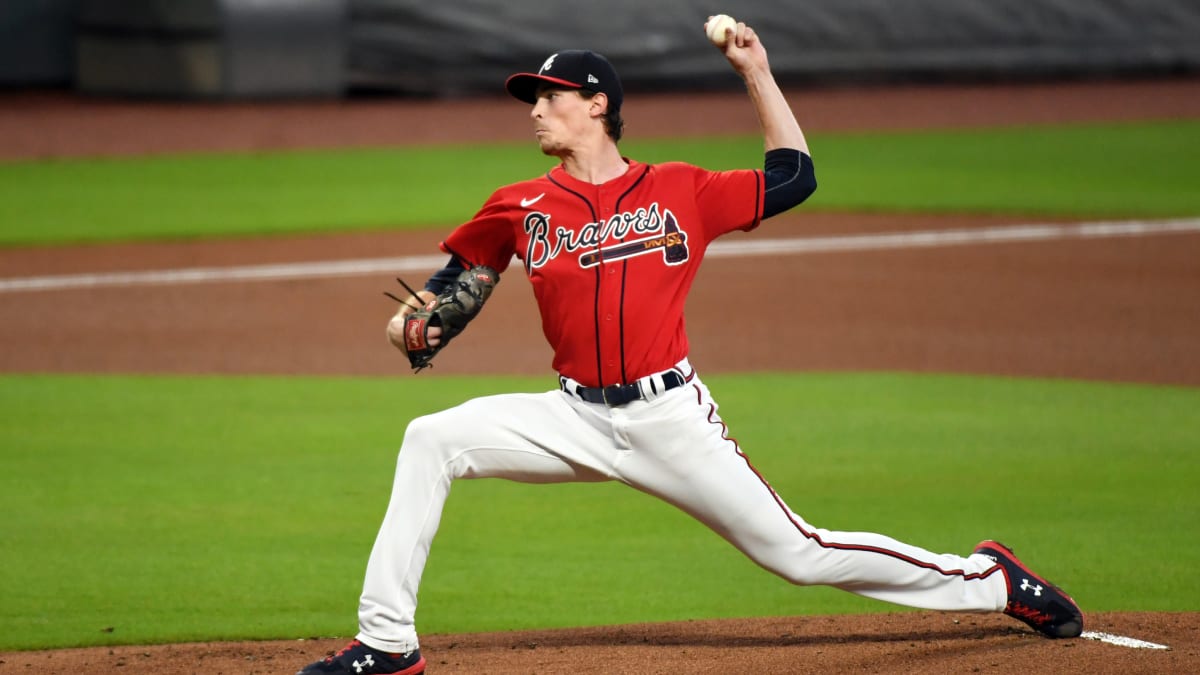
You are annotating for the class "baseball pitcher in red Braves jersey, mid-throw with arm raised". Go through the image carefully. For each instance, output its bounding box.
[301,15,1082,675]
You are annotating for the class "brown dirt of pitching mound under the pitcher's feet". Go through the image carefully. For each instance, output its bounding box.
[0,613,1200,675]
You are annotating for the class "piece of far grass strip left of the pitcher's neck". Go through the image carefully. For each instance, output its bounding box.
[0,145,548,245]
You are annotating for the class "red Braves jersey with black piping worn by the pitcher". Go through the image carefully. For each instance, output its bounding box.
[442,161,763,387]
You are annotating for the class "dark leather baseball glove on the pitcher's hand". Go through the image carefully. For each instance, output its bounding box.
[385,265,500,372]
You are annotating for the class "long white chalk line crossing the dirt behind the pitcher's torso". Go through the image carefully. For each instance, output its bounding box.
[0,219,1200,293]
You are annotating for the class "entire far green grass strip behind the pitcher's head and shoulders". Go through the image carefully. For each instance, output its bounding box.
[0,120,1200,245]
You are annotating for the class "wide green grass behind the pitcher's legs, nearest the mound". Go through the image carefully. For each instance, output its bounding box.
[0,374,1200,650]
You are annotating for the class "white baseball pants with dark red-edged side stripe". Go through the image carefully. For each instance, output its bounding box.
[358,376,1008,652]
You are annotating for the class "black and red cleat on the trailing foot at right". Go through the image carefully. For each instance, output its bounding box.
[974,540,1084,638]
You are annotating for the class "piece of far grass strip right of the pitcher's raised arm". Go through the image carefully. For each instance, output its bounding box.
[787,120,1200,217]
